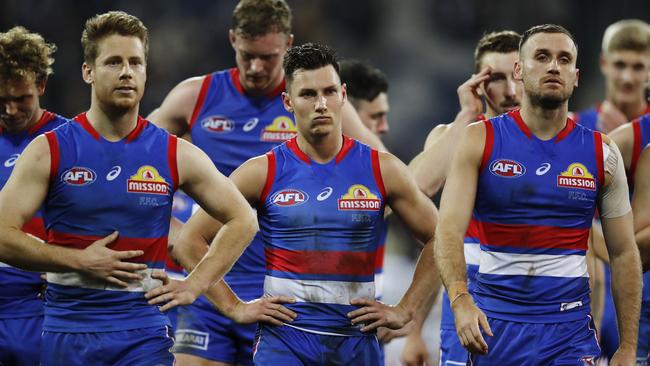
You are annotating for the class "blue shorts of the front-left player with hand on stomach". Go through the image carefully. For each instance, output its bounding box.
[41,326,174,366]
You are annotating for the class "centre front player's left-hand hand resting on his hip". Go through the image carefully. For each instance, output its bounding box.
[230,296,298,326]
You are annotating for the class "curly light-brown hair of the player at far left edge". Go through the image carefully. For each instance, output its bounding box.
[0,26,56,83]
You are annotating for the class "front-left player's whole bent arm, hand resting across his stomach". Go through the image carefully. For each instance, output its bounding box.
[0,136,146,286]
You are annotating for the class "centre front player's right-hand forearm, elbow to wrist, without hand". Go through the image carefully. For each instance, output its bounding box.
[392,241,440,327]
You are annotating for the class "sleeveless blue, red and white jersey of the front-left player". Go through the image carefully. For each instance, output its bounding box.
[43,114,178,332]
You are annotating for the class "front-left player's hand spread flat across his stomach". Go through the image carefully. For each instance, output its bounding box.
[79,231,147,287]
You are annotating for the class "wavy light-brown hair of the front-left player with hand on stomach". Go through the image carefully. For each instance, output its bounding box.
[81,11,149,64]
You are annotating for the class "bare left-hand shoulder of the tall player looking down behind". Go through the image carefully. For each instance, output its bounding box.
[147,76,203,137]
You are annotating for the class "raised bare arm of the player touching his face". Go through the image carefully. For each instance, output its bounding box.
[409,67,490,197]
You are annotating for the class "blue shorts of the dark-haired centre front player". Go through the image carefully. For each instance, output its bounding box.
[253,325,383,366]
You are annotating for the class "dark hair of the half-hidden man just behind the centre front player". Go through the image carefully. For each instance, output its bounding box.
[340,60,388,102]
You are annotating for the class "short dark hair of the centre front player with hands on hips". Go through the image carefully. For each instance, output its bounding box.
[282,43,340,84]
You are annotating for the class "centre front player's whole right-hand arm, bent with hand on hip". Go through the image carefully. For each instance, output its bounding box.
[349,153,440,331]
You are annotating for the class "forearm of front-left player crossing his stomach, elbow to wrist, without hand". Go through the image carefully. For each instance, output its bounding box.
[0,226,81,272]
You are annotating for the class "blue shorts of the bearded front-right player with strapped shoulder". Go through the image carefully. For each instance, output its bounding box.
[469,316,600,366]
